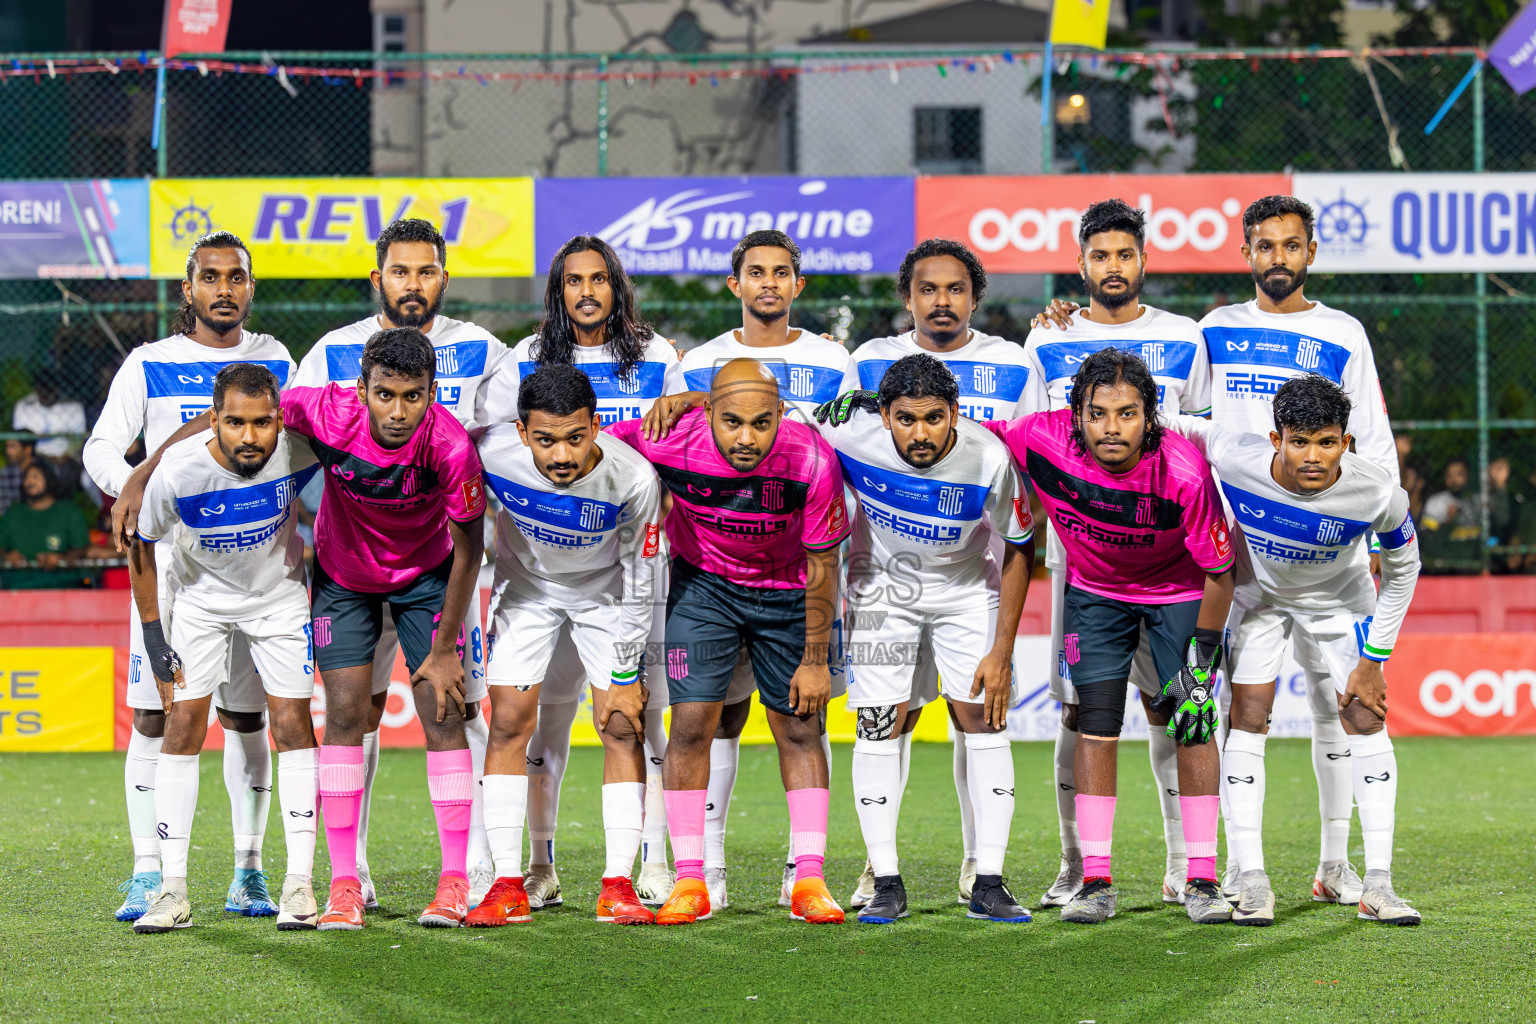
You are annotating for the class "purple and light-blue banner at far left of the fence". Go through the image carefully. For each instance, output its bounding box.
[0,178,149,278]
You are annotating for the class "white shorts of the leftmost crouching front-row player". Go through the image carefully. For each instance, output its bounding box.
[170,580,315,711]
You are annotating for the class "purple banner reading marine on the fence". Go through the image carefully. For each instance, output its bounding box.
[533,177,914,273]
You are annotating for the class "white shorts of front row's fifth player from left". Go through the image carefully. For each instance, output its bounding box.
[846,586,1018,711]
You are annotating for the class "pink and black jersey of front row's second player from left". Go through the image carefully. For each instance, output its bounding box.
[283,384,485,594]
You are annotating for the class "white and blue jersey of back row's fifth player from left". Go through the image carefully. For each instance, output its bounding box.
[840,330,1046,421]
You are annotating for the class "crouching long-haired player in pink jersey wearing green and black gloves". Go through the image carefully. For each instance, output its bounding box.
[989,348,1235,924]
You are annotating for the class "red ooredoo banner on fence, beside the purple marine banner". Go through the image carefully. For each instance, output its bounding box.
[917,173,1290,273]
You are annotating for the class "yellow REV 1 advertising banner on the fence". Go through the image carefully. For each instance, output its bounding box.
[149,178,533,277]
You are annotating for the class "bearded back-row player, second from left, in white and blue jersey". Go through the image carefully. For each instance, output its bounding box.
[296,218,511,909]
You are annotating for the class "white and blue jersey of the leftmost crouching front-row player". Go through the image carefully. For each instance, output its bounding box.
[138,431,318,622]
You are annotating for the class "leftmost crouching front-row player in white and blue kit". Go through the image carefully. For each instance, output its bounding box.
[129,362,327,933]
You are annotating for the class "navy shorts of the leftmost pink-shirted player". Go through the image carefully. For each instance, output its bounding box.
[309,551,453,672]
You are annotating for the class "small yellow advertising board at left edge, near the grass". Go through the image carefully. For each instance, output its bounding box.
[0,648,114,754]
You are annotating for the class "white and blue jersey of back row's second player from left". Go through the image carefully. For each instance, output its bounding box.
[296,313,511,427]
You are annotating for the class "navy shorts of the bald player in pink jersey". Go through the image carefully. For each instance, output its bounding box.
[667,557,823,715]
